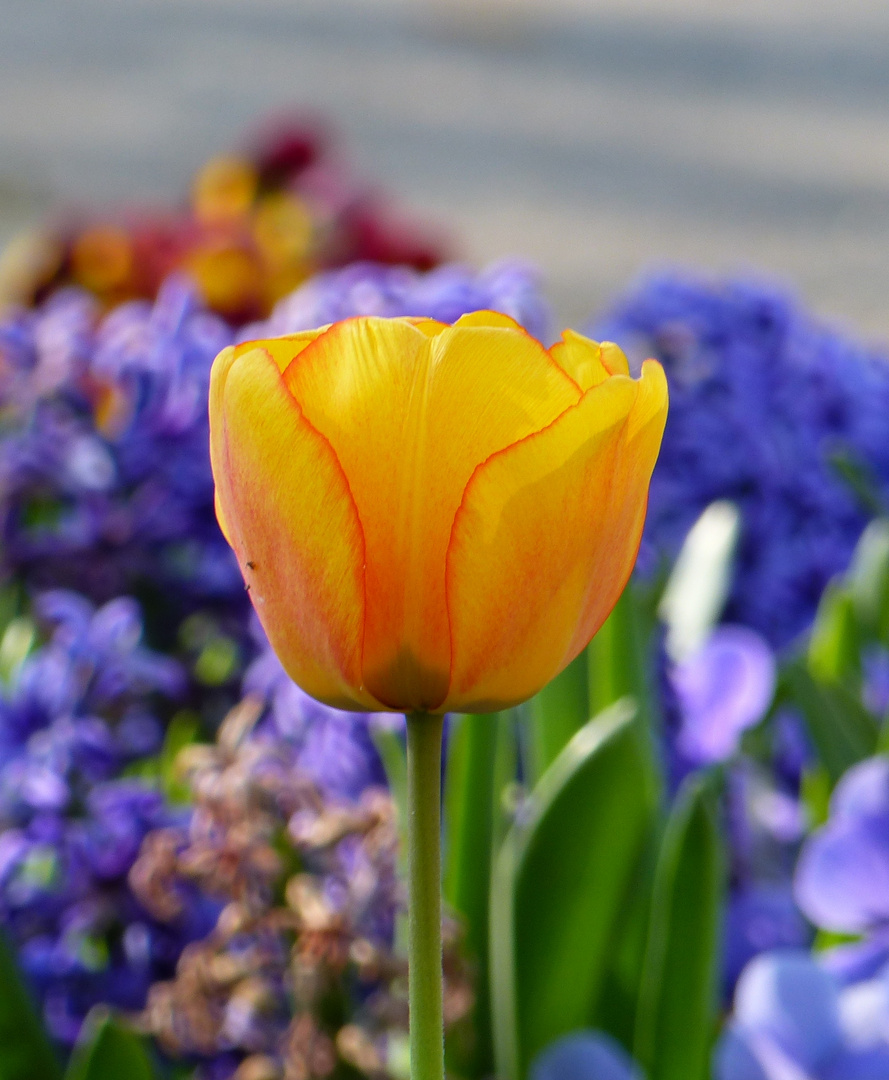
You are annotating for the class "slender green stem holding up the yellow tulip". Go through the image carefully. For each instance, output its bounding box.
[407,713,444,1080]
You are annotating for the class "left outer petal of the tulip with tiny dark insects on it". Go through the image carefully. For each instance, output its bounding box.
[211,342,380,710]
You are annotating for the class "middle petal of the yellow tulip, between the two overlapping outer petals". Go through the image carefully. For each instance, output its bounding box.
[284,313,580,710]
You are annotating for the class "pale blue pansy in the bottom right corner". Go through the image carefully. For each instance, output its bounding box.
[715,949,889,1080]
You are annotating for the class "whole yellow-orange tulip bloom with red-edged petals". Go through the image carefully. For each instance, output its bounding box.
[210,311,666,713]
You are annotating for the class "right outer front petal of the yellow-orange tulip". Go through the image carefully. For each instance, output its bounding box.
[442,363,666,712]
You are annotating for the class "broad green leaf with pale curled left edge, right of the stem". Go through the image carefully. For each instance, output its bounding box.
[490,701,654,1078]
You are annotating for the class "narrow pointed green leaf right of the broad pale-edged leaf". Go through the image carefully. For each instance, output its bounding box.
[634,774,726,1080]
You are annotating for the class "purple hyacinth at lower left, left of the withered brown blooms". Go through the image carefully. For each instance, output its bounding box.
[0,591,212,1043]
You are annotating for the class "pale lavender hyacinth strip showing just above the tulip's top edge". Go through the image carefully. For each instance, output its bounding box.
[238,261,551,341]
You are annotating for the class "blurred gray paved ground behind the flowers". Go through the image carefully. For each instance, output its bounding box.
[0,0,889,339]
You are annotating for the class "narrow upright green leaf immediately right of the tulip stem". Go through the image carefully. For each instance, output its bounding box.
[443,713,515,1077]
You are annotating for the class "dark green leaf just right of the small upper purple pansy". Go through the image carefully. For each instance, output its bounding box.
[779,661,878,785]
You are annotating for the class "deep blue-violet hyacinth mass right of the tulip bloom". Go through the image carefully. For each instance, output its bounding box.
[591,272,889,647]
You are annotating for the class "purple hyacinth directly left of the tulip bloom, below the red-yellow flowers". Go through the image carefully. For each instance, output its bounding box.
[0,279,244,610]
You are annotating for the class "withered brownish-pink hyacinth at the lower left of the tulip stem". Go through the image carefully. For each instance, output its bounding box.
[131,697,472,1080]
